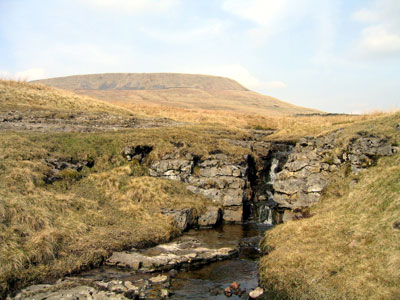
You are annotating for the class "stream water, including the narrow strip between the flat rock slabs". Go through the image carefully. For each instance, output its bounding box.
[79,223,272,299]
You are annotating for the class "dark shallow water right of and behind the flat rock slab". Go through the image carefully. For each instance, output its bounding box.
[170,224,270,299]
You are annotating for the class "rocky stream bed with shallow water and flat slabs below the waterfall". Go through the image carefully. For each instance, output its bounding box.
[11,223,271,300]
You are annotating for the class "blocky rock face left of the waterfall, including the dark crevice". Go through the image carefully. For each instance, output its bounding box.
[149,139,293,226]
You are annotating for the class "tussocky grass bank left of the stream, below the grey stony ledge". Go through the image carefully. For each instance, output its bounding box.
[0,130,219,296]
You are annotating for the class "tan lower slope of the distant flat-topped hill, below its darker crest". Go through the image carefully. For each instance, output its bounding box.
[74,88,318,116]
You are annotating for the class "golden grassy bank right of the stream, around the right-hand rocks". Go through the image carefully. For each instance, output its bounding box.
[260,113,400,300]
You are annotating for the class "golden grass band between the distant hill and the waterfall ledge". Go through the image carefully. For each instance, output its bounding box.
[112,102,395,140]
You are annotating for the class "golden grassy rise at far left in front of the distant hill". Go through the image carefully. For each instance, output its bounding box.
[0,80,177,132]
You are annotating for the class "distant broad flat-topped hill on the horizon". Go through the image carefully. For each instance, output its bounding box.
[35,73,318,116]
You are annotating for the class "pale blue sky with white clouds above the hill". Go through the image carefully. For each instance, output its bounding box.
[0,0,400,113]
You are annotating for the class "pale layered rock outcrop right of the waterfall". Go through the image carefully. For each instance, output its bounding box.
[273,131,395,222]
